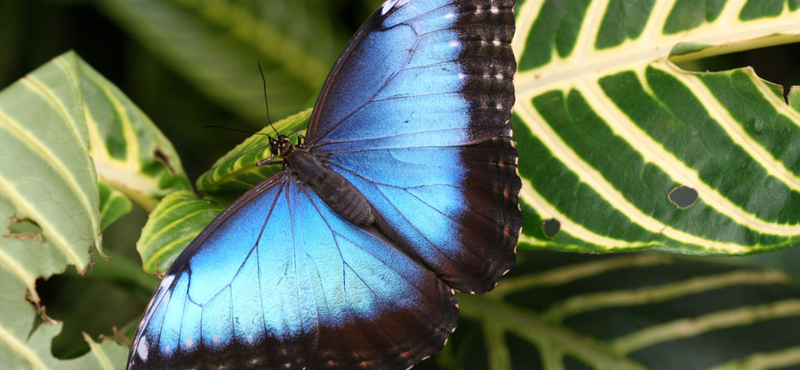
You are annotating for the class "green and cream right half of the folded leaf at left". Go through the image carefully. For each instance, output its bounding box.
[80,55,191,211]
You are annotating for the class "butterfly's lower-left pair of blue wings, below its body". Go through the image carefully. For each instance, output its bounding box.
[128,171,458,370]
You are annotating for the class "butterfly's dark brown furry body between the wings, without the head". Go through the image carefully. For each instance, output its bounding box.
[280,140,375,226]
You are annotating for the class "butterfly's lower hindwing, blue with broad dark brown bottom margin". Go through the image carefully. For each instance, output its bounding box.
[291,178,458,369]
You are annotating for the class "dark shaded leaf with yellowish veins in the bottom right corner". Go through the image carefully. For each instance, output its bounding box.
[415,251,800,370]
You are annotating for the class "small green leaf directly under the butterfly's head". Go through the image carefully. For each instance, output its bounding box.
[197,109,311,203]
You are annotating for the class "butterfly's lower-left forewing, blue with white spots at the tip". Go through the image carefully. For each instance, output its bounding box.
[128,173,319,369]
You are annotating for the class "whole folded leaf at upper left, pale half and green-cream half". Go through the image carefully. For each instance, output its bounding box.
[0,49,191,271]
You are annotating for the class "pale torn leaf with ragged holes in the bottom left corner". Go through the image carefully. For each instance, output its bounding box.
[0,189,128,370]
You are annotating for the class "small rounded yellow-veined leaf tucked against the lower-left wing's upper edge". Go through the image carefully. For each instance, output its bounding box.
[136,191,223,275]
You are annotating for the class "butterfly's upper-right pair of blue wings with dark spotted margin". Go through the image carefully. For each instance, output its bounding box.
[307,0,522,293]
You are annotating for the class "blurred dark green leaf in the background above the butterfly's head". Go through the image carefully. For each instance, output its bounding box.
[98,0,345,126]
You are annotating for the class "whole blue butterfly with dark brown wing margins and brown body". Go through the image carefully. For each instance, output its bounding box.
[128,0,522,370]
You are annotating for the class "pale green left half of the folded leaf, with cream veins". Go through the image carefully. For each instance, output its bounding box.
[0,49,101,271]
